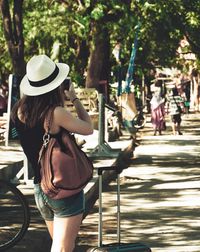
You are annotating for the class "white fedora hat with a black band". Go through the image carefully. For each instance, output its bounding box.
[20,55,69,96]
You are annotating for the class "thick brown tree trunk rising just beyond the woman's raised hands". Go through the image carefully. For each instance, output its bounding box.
[86,24,110,90]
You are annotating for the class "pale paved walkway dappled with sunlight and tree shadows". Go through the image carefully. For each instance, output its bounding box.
[0,114,200,252]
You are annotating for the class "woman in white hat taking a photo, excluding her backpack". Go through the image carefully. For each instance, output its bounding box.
[12,55,93,252]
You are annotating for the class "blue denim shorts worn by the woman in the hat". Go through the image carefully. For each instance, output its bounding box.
[34,184,85,221]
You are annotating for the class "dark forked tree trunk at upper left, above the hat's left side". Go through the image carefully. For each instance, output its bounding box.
[0,0,25,76]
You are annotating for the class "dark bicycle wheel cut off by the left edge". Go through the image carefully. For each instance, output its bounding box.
[0,180,30,251]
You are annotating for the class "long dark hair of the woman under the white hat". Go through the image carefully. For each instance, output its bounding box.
[11,85,64,128]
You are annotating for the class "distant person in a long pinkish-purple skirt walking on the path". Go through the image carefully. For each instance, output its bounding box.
[150,90,166,136]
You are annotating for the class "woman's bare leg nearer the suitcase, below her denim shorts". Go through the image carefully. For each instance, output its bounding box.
[51,214,83,252]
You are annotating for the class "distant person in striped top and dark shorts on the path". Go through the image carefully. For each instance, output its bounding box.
[167,87,183,135]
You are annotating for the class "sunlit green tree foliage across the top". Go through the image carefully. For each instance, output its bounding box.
[0,0,200,85]
